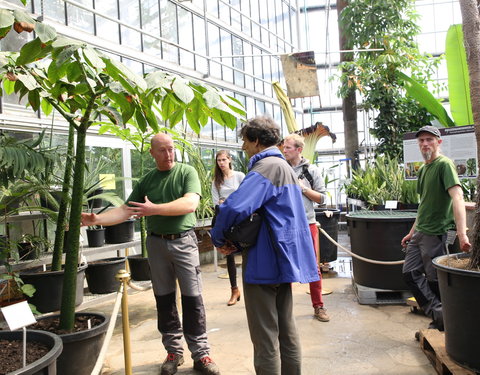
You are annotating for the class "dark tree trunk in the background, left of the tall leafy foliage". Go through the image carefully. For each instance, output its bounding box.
[337,0,358,177]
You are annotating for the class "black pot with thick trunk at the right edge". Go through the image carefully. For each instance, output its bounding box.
[433,0,480,372]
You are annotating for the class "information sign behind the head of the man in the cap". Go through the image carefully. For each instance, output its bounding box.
[403,125,477,179]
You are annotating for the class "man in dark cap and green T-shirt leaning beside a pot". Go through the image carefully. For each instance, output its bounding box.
[402,126,471,331]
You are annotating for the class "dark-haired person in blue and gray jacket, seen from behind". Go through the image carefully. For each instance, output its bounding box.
[212,116,318,375]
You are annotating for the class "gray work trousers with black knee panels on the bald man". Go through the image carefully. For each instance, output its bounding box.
[147,230,210,361]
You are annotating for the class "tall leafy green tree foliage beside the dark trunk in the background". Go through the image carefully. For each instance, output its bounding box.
[339,0,440,160]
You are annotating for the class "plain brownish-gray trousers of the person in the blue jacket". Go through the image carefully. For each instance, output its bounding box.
[243,282,302,375]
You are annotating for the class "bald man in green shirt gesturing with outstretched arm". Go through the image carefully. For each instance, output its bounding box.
[82,134,220,375]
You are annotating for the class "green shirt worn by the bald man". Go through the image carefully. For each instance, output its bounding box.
[127,163,201,234]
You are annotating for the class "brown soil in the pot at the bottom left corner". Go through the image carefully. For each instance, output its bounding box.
[0,340,50,375]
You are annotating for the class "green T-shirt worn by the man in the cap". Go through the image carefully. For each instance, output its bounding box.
[416,155,460,235]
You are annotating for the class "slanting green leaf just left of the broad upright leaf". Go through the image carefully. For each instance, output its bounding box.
[397,72,455,127]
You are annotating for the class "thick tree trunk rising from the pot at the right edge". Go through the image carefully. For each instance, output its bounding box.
[460,0,480,268]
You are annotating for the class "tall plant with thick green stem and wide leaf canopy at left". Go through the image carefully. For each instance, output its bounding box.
[1,5,244,374]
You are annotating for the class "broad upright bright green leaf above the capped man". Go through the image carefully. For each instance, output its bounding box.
[445,25,473,125]
